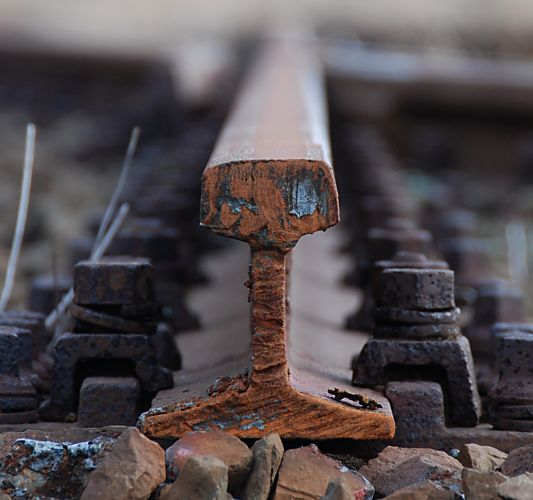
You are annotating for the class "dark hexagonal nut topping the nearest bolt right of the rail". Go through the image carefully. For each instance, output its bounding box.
[379,268,455,311]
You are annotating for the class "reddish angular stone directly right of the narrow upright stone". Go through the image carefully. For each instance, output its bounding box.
[274,444,374,500]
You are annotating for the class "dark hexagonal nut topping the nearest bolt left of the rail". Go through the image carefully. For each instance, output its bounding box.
[74,257,155,305]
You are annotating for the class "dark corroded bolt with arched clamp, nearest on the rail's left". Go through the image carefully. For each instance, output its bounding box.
[40,257,175,426]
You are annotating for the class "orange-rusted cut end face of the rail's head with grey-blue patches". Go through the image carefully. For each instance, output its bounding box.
[201,160,339,249]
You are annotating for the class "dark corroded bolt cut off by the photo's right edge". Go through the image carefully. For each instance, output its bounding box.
[489,323,533,432]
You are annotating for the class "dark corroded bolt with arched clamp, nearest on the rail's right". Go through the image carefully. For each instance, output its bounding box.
[353,262,480,426]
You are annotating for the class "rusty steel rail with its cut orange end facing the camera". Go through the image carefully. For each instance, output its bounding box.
[138,36,394,439]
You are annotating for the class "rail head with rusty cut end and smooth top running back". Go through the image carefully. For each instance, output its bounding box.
[200,36,339,250]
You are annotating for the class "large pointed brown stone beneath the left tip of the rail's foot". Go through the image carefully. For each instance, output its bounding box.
[81,427,165,500]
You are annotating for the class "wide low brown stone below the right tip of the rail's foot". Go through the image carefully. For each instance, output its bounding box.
[360,446,463,496]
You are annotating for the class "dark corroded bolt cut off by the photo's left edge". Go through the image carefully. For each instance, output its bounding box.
[0,326,38,424]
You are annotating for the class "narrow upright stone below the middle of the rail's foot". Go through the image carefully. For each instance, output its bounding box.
[242,434,283,500]
